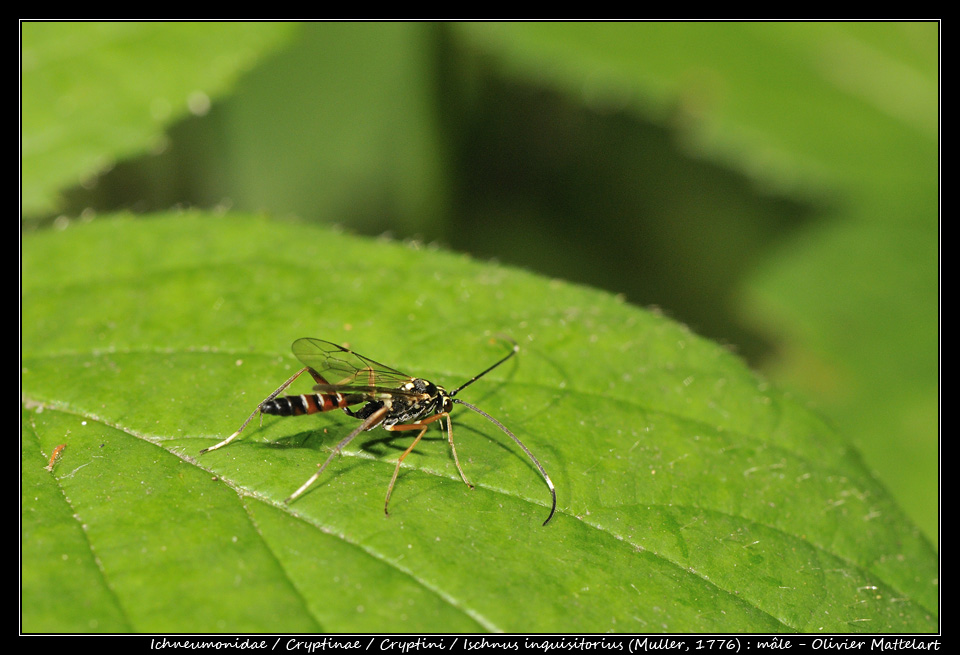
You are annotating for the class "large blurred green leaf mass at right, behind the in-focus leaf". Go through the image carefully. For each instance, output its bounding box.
[455,21,940,539]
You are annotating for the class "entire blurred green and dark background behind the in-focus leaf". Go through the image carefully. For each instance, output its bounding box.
[21,22,939,542]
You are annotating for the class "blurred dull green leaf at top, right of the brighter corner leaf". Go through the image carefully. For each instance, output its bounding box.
[206,22,451,235]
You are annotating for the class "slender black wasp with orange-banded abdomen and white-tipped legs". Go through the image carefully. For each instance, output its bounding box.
[200,338,557,525]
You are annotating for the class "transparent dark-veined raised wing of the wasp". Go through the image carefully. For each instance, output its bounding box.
[292,337,411,393]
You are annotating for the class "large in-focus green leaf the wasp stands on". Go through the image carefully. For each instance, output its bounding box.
[21,214,938,633]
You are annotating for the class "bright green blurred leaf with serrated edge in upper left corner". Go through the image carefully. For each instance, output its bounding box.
[21,22,290,215]
